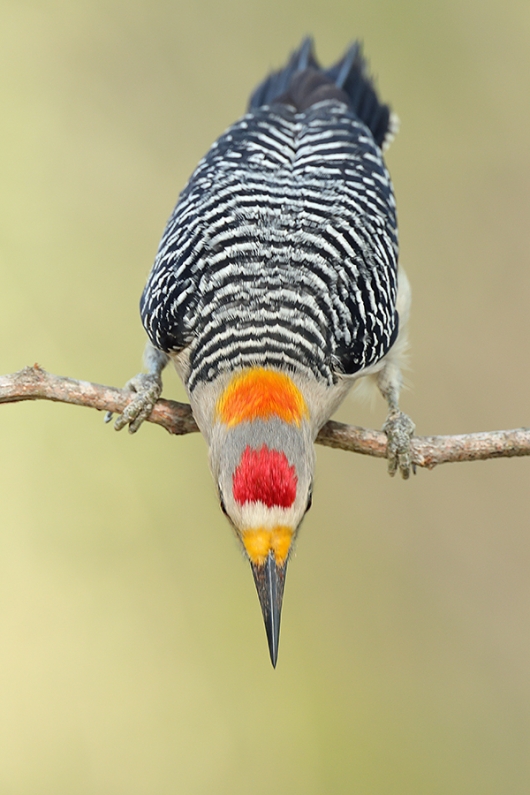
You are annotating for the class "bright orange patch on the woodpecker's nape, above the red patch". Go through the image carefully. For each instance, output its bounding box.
[217,367,309,427]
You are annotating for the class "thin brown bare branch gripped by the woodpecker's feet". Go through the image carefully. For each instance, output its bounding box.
[0,364,530,469]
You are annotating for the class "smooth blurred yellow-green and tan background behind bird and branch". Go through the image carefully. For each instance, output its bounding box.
[0,0,530,795]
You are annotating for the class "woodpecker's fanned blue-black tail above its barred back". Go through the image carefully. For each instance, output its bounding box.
[250,38,398,149]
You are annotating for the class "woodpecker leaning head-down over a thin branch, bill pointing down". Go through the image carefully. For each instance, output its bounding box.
[108,39,414,666]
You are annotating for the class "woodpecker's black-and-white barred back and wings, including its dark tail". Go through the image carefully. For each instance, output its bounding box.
[141,40,399,392]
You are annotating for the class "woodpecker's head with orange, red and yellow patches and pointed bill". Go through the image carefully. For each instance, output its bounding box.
[205,368,314,666]
